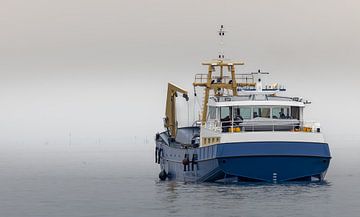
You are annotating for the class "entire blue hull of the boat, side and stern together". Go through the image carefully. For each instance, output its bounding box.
[157,136,331,182]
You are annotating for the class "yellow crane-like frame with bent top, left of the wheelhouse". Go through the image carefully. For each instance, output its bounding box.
[164,83,189,138]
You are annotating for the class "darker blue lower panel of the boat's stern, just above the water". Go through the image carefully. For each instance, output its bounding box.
[219,156,330,182]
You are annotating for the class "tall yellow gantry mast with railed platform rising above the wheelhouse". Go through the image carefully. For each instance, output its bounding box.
[193,60,256,124]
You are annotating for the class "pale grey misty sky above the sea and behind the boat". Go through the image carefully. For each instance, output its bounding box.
[0,0,360,144]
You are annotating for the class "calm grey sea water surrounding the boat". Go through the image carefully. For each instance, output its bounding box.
[0,138,360,217]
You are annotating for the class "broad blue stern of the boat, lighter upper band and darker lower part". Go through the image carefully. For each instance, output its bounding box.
[216,142,331,182]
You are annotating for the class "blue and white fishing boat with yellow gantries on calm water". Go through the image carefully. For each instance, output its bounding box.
[155,26,331,183]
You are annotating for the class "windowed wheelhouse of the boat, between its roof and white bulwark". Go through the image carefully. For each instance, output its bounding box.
[207,100,305,132]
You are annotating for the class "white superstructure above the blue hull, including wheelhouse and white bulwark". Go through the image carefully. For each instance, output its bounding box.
[200,73,324,146]
